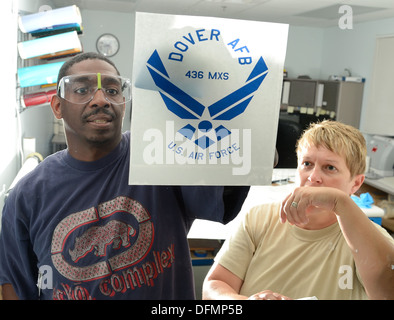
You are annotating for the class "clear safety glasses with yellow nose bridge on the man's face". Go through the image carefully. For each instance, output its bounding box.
[58,73,131,104]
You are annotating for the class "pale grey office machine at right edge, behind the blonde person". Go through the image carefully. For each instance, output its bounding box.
[364,134,394,179]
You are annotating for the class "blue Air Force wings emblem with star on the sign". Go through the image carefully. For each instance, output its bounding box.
[147,50,268,149]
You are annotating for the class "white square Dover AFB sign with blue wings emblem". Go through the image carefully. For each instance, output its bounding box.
[129,13,288,185]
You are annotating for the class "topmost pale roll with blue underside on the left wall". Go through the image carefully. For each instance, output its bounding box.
[18,5,82,36]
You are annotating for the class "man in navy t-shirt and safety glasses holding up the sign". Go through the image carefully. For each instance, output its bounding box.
[0,53,248,300]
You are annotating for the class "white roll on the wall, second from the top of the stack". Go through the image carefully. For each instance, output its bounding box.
[18,31,82,59]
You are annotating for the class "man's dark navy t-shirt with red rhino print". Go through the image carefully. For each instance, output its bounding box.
[0,133,248,300]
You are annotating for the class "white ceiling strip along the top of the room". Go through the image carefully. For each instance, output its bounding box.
[52,0,394,27]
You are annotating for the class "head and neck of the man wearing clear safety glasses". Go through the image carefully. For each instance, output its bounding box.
[52,59,131,161]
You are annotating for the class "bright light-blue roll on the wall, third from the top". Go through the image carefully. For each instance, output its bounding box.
[18,61,64,88]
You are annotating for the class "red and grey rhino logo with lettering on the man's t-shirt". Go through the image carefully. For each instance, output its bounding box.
[51,196,174,299]
